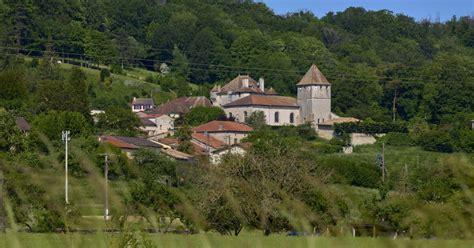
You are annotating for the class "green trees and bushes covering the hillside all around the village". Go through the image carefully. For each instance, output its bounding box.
[0,0,474,242]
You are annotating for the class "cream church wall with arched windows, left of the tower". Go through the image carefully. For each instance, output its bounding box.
[224,106,299,126]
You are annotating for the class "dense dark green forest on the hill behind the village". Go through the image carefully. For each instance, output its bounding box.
[0,0,474,124]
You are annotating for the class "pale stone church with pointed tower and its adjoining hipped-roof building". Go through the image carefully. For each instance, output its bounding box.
[211,64,356,135]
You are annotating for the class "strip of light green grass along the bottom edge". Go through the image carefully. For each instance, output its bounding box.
[0,233,474,248]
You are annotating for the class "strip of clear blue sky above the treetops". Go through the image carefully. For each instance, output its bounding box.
[261,0,474,22]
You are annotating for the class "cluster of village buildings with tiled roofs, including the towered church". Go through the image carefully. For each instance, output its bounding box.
[92,64,376,164]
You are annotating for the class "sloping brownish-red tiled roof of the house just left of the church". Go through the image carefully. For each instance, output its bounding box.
[152,96,212,114]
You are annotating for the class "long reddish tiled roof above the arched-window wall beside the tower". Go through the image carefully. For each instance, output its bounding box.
[223,95,299,108]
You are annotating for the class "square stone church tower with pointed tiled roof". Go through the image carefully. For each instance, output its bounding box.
[296,64,331,126]
